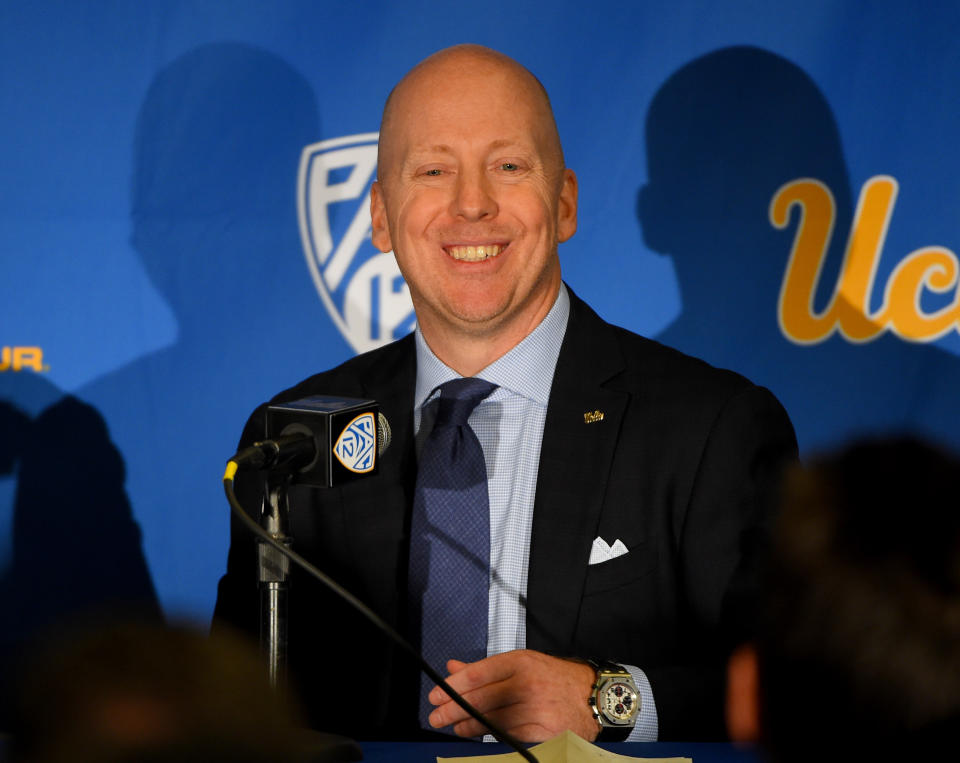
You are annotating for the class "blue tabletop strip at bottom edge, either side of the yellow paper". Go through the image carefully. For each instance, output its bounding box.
[360,742,761,763]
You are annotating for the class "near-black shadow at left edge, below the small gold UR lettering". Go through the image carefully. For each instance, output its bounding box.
[0,371,162,728]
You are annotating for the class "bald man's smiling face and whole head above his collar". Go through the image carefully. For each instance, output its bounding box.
[371,47,577,370]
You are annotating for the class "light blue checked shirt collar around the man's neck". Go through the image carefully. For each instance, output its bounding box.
[413,283,570,410]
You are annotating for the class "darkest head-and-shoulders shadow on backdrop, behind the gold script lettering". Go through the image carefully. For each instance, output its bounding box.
[637,47,960,452]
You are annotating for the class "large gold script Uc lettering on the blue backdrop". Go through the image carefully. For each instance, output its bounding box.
[769,175,960,344]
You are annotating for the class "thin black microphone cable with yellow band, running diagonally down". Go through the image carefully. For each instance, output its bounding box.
[223,460,537,763]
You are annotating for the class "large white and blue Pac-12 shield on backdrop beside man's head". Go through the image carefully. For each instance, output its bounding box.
[297,132,414,353]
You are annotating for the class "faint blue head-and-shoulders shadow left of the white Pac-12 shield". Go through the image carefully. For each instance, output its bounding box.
[79,43,329,620]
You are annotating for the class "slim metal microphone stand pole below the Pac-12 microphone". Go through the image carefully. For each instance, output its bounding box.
[257,472,292,688]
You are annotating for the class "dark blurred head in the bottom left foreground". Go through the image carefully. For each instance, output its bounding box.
[13,624,359,763]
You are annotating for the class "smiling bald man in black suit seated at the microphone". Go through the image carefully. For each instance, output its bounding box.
[216,46,796,741]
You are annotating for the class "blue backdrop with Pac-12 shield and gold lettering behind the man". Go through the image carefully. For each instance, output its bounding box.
[0,0,960,639]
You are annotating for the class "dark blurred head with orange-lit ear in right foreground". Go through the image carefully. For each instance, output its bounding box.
[728,439,960,763]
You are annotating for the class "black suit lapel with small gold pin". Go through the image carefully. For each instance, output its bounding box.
[527,292,628,654]
